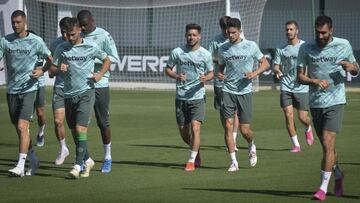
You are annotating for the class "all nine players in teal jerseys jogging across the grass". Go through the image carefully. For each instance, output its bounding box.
[0,7,359,200]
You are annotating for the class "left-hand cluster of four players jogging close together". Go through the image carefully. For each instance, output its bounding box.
[0,10,119,178]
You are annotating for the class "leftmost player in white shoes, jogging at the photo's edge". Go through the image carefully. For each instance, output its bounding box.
[0,10,52,177]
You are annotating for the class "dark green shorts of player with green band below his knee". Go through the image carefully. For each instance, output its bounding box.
[65,89,95,129]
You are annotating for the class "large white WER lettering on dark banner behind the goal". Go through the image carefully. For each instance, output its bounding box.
[110,56,169,72]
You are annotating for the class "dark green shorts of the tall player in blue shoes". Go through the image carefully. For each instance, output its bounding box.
[94,87,110,130]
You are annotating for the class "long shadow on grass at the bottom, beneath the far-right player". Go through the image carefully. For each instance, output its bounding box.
[183,188,360,200]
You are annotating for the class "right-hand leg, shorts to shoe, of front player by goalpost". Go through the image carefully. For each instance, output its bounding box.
[237,93,257,167]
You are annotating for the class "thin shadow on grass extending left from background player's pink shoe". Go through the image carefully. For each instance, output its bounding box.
[128,144,290,151]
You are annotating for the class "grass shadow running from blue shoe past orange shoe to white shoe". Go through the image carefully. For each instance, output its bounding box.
[113,161,224,170]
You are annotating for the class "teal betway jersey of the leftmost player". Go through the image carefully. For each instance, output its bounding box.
[0,33,50,94]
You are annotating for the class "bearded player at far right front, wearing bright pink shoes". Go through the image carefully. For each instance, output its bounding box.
[298,16,359,200]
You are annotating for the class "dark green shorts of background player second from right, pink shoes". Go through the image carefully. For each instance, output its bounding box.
[280,91,309,111]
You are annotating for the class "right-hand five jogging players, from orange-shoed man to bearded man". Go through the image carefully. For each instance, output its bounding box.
[166,16,359,200]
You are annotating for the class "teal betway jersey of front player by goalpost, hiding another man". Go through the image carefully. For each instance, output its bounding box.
[219,39,264,95]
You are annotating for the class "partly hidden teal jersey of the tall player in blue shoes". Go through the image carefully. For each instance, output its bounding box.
[83,27,119,88]
